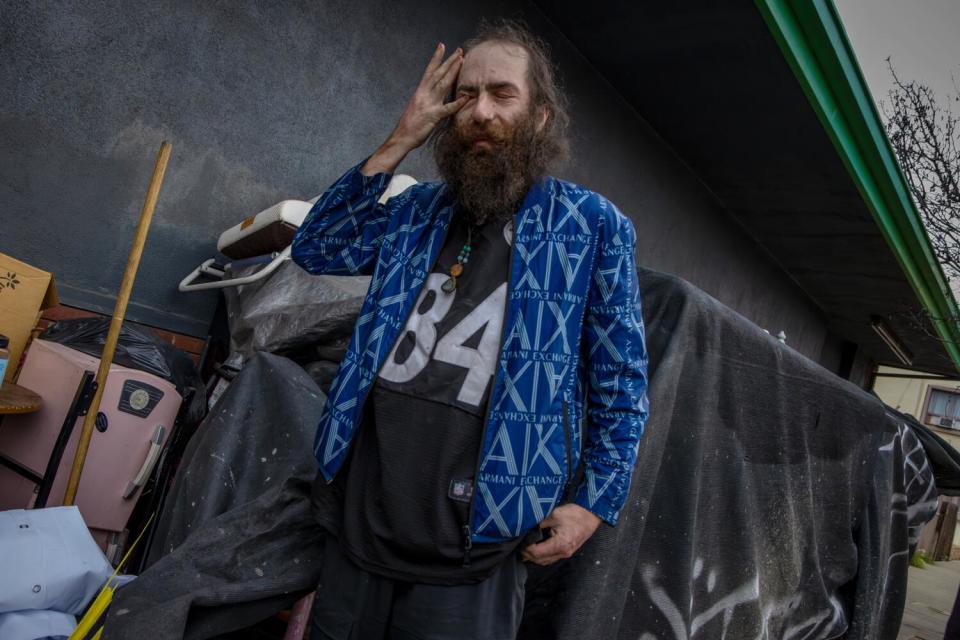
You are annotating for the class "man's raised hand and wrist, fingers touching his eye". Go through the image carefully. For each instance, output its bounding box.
[360,43,468,176]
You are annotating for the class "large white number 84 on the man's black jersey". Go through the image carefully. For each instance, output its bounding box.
[380,273,507,406]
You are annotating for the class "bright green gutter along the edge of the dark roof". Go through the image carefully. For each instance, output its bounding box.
[754,0,960,371]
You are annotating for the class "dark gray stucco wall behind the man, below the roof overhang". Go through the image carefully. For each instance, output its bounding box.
[0,0,825,358]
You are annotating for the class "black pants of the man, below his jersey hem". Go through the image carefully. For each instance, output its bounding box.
[310,538,527,640]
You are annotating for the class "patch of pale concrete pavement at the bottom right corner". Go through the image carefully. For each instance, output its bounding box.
[897,560,960,640]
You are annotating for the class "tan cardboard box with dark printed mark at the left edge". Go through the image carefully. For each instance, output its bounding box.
[0,253,58,382]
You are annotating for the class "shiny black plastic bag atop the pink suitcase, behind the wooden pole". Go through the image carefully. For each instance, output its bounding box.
[40,316,206,424]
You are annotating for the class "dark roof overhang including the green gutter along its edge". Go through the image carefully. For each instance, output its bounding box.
[534,0,960,375]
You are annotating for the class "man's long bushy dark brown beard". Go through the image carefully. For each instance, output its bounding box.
[434,114,545,224]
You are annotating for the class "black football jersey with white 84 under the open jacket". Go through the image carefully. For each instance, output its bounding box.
[340,216,519,584]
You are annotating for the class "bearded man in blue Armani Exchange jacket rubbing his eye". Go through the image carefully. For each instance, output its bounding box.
[293,23,647,638]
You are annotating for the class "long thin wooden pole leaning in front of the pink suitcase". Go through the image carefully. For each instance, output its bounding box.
[63,140,170,506]
